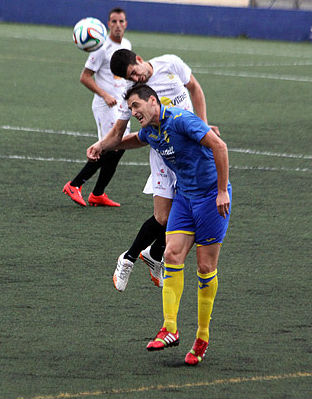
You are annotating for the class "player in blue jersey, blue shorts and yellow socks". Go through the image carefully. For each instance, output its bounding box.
[88,84,232,365]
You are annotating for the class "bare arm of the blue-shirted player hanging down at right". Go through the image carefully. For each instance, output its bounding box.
[200,132,230,218]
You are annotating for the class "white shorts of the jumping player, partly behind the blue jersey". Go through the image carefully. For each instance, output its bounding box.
[143,148,177,199]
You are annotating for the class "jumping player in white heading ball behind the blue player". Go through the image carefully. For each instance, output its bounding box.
[87,50,218,291]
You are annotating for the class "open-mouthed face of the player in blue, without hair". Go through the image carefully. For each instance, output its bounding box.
[128,94,159,127]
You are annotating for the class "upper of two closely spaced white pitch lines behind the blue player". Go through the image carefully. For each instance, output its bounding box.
[0,125,312,159]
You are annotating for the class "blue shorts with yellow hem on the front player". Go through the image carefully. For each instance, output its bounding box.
[166,184,232,245]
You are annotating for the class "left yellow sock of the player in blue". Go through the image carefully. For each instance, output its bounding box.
[162,263,184,334]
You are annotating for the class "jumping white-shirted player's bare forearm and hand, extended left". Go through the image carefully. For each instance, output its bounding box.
[87,119,128,162]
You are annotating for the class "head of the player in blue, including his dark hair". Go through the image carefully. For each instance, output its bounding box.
[125,83,161,127]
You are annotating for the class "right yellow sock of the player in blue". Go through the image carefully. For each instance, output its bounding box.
[196,269,218,342]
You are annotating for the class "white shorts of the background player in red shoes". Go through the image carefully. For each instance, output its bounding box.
[92,102,130,140]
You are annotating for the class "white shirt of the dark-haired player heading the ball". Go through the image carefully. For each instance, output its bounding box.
[119,54,193,120]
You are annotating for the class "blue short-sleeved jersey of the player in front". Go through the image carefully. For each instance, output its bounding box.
[139,105,218,198]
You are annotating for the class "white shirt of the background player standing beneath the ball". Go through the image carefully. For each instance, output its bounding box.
[85,37,131,106]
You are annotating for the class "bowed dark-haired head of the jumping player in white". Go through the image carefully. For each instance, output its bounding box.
[110,49,153,83]
